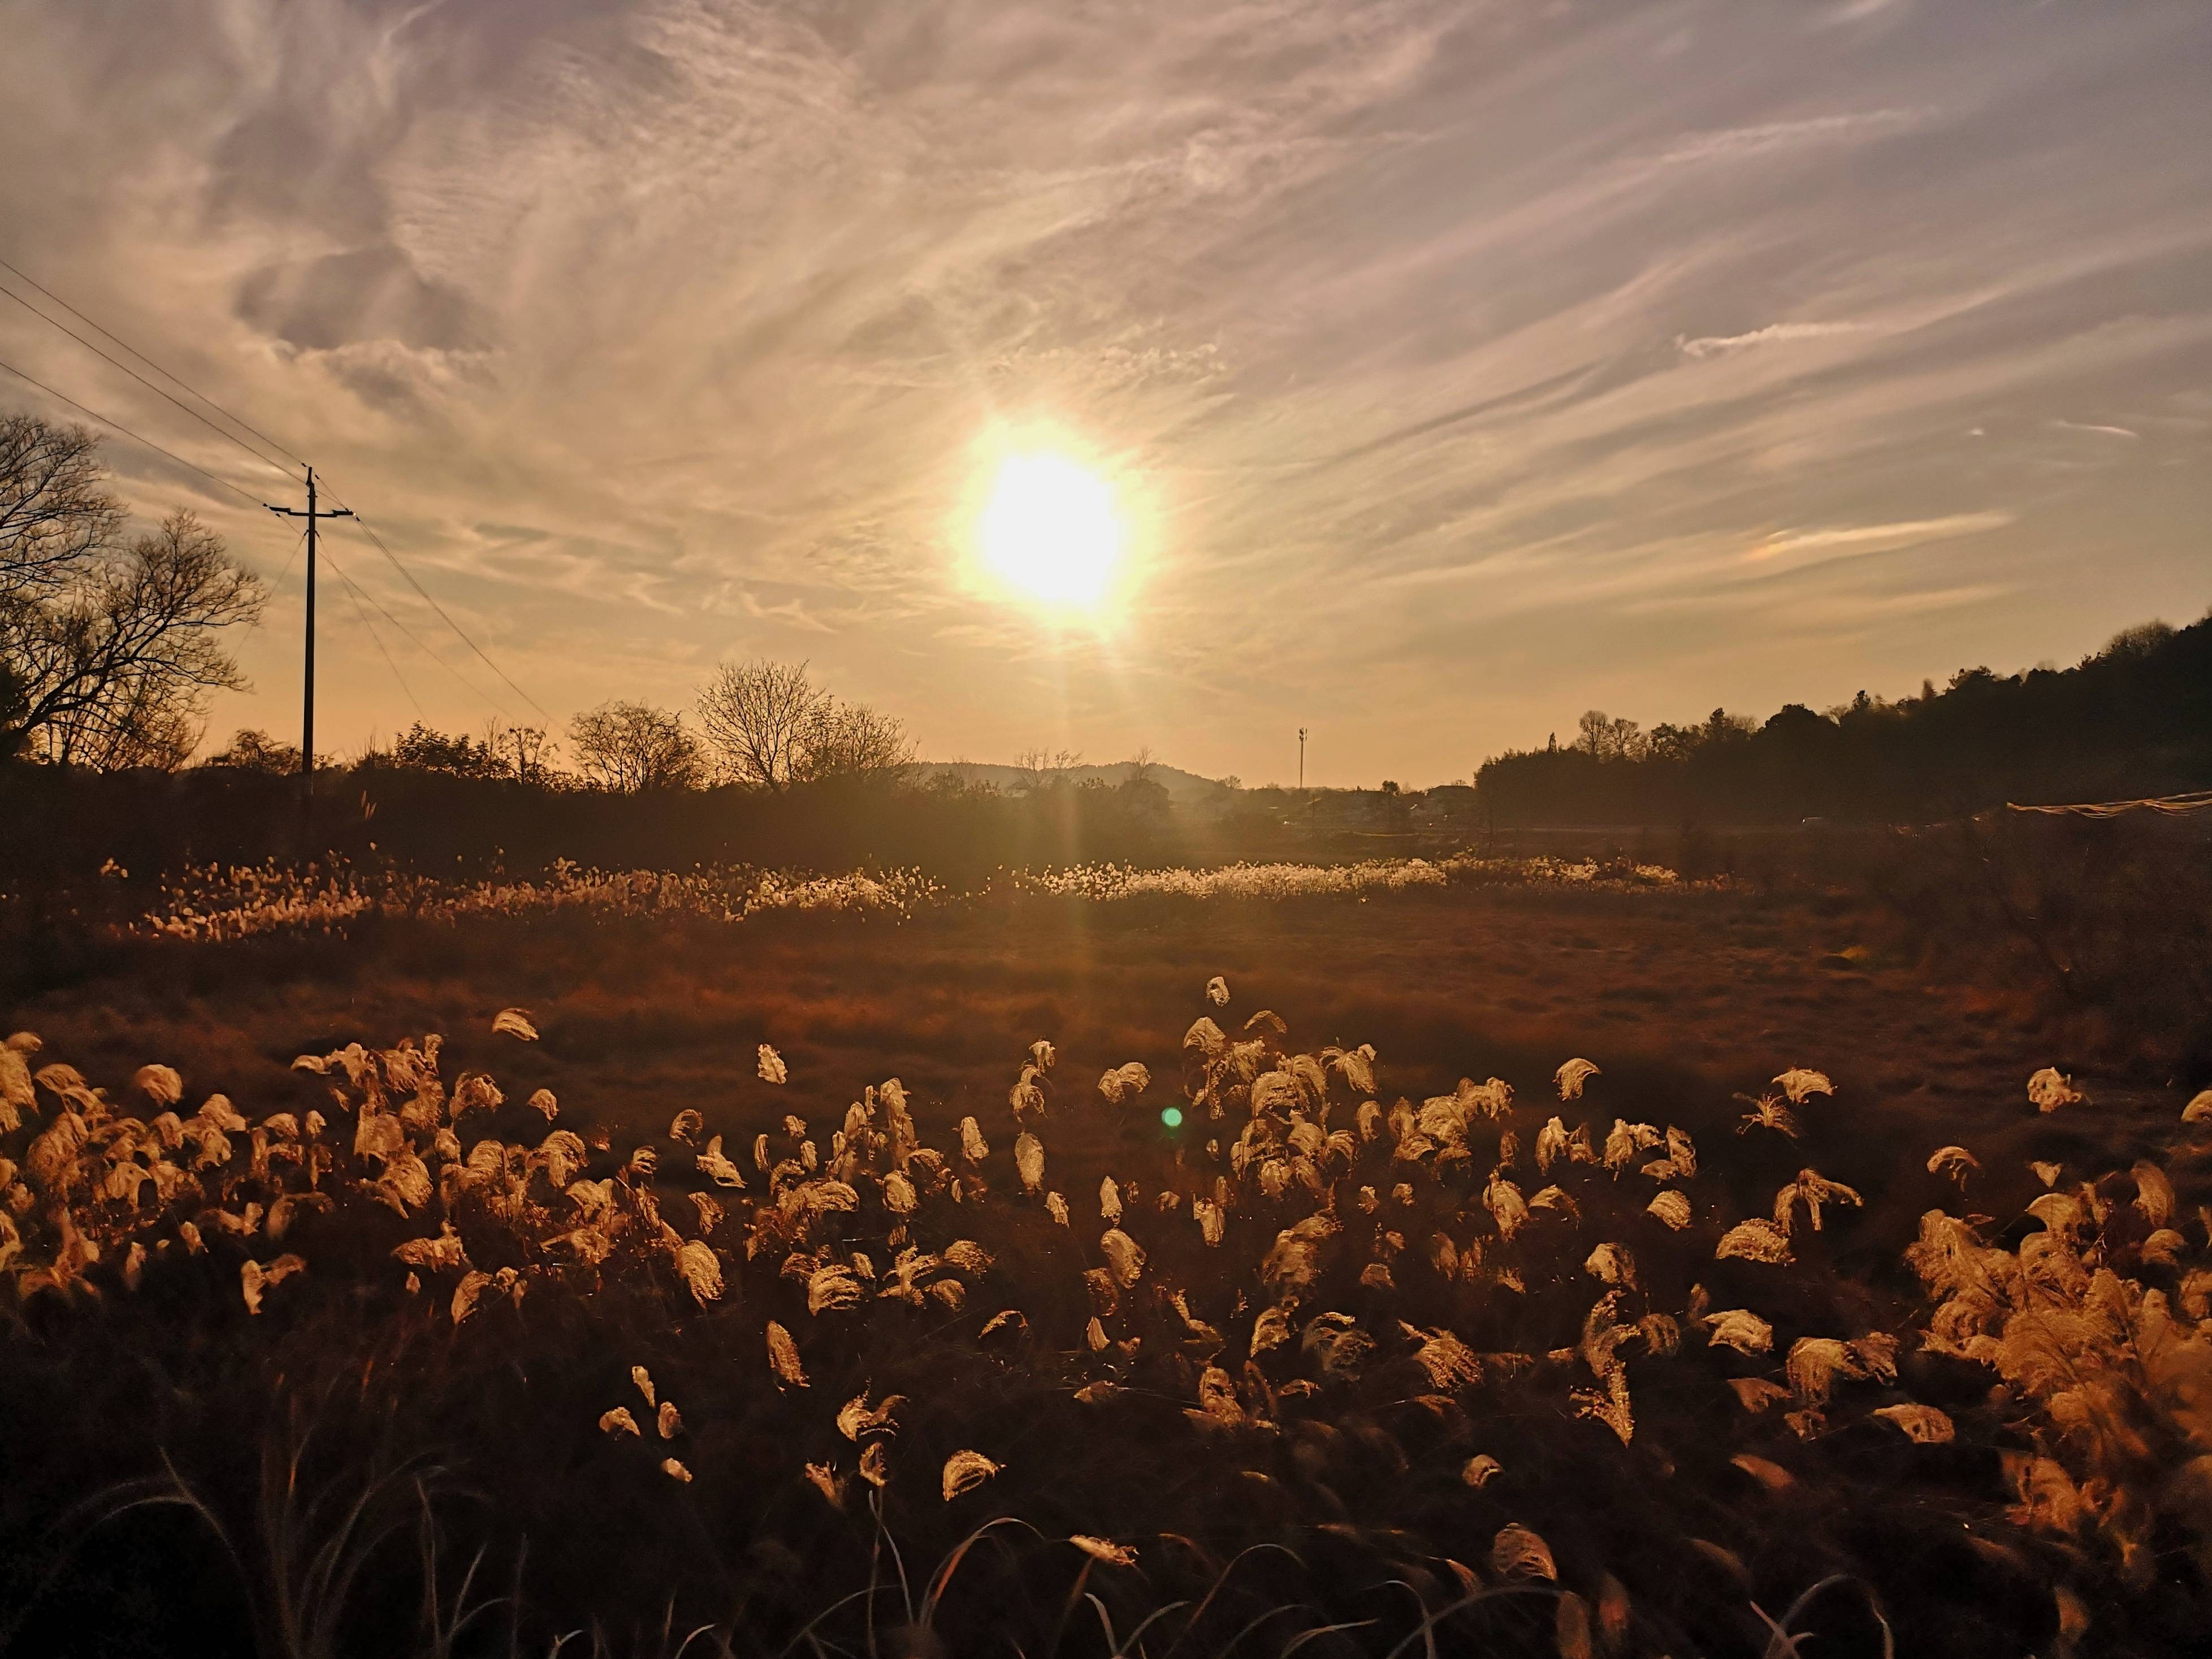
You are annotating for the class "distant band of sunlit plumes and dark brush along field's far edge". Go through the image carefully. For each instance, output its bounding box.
[12,814,2212,1086]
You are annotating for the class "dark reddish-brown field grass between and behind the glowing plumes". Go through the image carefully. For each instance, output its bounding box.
[0,876,2205,1659]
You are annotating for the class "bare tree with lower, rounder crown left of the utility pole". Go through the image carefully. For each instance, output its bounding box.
[0,513,267,768]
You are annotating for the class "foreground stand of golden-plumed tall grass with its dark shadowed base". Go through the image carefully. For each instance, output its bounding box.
[0,955,2212,1654]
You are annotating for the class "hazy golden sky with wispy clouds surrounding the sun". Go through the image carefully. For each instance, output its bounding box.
[0,0,2212,785]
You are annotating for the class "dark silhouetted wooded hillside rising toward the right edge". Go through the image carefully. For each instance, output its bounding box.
[1475,615,2212,828]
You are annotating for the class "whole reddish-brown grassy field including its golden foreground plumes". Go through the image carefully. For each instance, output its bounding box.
[0,882,2212,1659]
